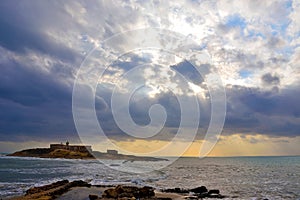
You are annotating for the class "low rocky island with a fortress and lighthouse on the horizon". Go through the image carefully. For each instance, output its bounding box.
[7,141,167,161]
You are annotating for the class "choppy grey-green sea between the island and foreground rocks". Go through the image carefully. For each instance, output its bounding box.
[0,156,300,200]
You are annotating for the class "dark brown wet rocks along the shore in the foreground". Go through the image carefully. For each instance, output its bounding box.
[6,180,225,200]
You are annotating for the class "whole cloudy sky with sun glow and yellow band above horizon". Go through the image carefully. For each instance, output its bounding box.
[0,0,300,156]
